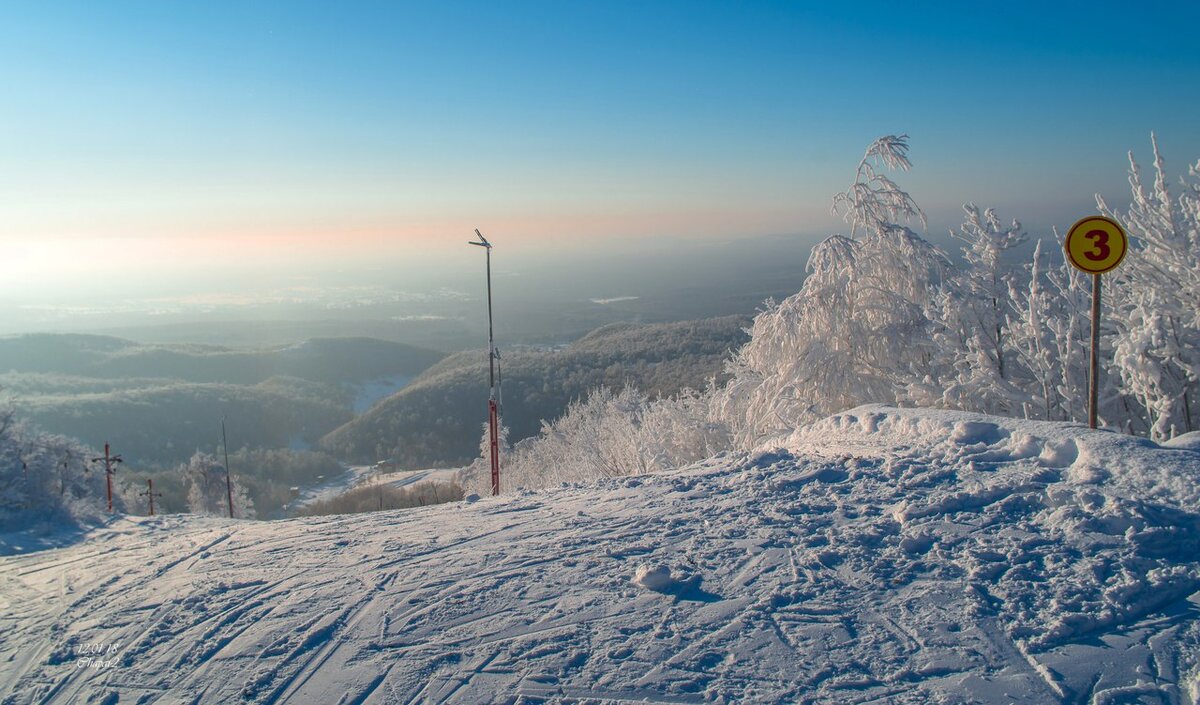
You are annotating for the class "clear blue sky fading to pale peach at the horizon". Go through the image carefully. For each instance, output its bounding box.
[0,0,1200,309]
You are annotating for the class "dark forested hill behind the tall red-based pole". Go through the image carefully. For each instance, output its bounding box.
[322,317,750,466]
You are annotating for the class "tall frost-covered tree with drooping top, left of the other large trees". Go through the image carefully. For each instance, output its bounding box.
[716,135,947,444]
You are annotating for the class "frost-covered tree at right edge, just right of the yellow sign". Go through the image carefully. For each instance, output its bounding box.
[1097,134,1200,440]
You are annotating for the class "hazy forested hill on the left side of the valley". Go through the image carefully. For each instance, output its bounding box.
[0,335,443,468]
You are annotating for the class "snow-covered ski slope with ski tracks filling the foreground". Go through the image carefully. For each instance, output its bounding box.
[0,406,1200,705]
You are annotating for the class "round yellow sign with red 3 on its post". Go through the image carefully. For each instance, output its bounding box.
[1063,216,1129,428]
